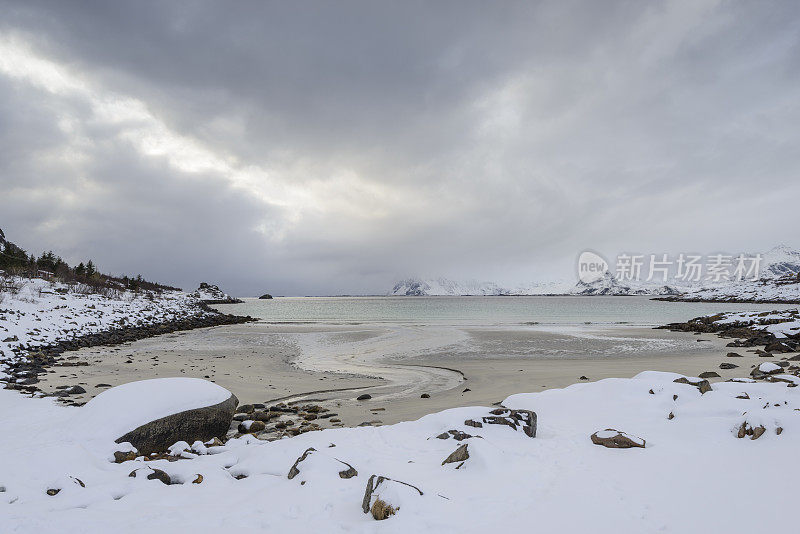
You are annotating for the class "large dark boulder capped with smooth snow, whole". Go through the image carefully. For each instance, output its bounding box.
[78,378,239,454]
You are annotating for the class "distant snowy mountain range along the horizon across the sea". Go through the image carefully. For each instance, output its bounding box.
[388,245,800,301]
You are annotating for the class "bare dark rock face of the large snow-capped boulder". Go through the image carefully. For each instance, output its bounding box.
[114,393,238,455]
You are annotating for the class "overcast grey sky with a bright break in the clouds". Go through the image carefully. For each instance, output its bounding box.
[0,0,800,295]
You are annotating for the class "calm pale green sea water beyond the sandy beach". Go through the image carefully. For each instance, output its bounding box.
[215,297,796,326]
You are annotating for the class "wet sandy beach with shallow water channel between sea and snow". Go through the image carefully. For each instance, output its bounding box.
[32,323,788,426]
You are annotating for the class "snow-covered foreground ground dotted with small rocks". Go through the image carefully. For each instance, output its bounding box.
[0,372,800,533]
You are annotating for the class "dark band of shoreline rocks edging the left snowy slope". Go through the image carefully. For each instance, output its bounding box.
[0,303,257,397]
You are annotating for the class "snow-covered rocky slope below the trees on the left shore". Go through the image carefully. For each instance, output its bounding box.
[0,277,213,378]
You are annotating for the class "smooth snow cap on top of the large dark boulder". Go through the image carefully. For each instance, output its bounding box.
[73,377,231,452]
